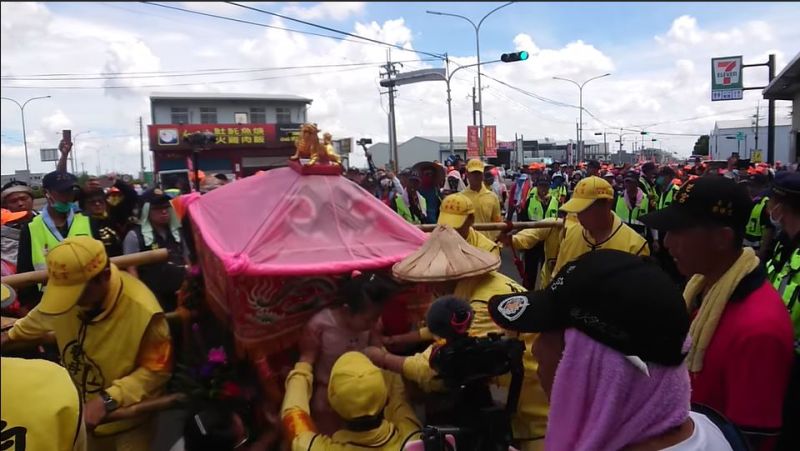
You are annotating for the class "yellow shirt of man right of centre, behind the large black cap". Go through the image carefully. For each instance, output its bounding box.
[552,212,650,275]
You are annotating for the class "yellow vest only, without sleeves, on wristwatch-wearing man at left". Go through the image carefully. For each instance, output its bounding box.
[49,264,163,436]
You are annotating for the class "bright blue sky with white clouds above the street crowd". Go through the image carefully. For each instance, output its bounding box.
[0,2,800,174]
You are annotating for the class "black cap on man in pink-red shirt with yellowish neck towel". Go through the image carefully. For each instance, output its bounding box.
[639,175,753,232]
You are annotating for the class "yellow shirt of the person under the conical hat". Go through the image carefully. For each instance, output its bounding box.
[403,271,549,449]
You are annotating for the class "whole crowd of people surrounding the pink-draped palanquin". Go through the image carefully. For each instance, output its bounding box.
[2,139,800,451]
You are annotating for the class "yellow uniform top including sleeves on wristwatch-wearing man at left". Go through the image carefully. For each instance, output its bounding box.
[8,265,172,436]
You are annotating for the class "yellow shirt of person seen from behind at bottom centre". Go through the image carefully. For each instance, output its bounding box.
[281,362,421,451]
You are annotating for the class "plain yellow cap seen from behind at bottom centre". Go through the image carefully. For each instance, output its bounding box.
[328,351,389,420]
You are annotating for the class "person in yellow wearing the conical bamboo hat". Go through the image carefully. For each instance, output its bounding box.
[364,226,548,449]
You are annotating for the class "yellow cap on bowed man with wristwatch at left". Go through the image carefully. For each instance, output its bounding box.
[39,236,108,315]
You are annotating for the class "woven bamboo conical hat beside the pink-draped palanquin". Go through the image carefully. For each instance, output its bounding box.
[392,226,500,282]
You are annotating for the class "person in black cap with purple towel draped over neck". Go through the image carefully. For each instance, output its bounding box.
[489,250,748,451]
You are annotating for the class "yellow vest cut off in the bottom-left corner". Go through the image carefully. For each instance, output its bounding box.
[0,357,86,451]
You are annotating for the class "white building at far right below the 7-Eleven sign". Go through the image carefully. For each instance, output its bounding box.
[708,118,795,163]
